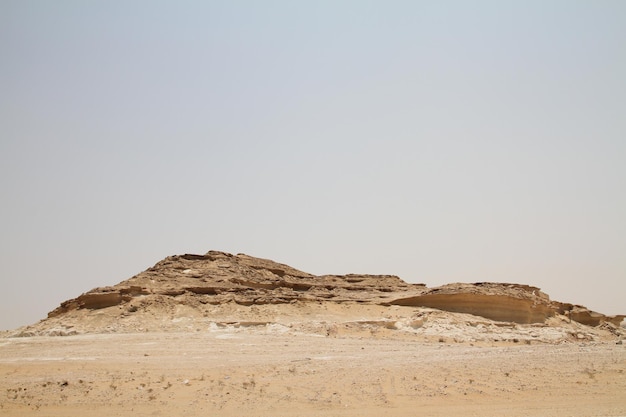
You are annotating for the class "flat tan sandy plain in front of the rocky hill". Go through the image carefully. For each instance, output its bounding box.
[0,324,626,417]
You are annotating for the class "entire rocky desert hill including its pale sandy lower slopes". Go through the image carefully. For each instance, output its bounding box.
[12,251,626,340]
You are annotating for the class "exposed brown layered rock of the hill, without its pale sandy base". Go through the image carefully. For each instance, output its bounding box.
[41,251,625,326]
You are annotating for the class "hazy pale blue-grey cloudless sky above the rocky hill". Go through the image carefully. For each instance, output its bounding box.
[0,0,626,329]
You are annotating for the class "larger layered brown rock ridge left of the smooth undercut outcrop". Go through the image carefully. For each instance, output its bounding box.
[48,251,425,317]
